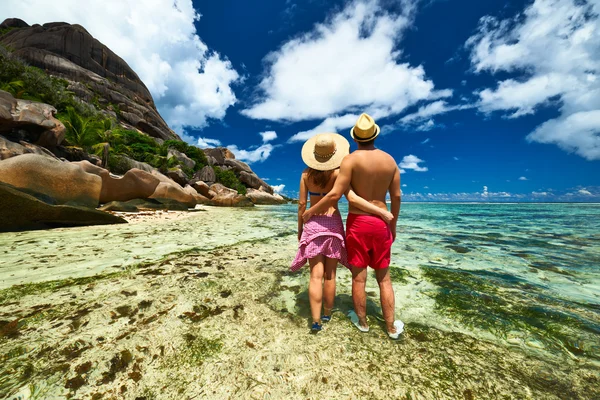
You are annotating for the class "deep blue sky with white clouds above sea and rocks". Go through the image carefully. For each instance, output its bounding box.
[0,0,600,202]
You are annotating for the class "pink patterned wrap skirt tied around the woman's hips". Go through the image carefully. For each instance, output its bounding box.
[290,213,350,271]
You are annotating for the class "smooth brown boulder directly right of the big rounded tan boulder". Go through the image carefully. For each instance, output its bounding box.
[73,161,160,203]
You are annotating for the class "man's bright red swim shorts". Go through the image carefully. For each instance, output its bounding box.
[346,213,394,269]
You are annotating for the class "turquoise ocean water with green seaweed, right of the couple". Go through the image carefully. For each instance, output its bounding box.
[272,203,600,363]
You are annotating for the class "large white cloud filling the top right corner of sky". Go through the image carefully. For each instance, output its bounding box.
[467,0,600,160]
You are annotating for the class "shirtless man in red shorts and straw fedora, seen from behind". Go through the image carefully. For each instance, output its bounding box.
[303,114,404,339]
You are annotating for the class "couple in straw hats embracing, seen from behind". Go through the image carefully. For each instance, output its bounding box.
[290,114,404,339]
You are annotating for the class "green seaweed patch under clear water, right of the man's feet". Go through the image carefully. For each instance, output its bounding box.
[421,265,600,358]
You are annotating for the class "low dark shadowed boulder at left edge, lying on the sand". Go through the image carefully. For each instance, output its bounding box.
[0,181,127,231]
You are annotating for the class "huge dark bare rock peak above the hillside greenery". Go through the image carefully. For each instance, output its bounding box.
[0,21,180,140]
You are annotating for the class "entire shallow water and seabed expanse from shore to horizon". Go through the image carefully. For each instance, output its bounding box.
[0,204,600,399]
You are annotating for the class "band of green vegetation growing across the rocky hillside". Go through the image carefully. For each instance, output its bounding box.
[0,46,246,194]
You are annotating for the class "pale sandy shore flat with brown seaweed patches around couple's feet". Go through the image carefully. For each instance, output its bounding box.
[0,207,600,399]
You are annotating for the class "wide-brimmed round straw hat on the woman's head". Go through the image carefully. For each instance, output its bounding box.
[302,133,350,171]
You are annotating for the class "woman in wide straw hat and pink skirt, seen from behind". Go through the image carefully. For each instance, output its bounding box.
[290,133,392,333]
